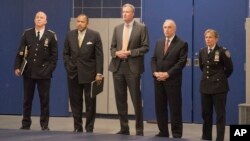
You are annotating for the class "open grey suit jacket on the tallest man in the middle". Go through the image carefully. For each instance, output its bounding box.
[109,21,149,74]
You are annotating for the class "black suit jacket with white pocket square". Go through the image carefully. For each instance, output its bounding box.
[63,28,103,83]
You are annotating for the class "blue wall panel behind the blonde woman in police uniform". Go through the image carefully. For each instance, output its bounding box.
[193,0,248,124]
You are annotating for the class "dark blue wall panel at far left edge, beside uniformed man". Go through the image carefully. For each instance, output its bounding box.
[0,0,23,114]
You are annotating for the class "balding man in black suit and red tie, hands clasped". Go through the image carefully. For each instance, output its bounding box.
[151,19,188,138]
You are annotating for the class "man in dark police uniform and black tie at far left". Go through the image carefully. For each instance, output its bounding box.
[14,11,58,130]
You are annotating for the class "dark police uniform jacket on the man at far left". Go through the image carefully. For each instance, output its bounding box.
[14,28,58,79]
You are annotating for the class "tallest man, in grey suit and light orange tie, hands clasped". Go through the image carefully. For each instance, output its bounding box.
[109,4,149,135]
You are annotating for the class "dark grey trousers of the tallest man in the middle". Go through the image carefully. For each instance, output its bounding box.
[113,61,143,134]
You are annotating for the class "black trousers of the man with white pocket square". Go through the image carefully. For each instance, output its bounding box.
[68,77,96,131]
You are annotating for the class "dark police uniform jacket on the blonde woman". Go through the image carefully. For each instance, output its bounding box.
[199,45,233,94]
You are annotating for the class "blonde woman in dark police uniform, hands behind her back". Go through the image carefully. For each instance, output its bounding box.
[199,29,233,141]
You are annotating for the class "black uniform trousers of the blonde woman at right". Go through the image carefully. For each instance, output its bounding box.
[201,93,227,141]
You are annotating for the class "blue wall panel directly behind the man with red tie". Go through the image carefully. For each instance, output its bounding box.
[142,0,192,122]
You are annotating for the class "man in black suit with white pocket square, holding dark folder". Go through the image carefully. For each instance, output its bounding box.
[63,14,103,133]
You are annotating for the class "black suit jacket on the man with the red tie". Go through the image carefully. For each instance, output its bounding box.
[151,36,188,85]
